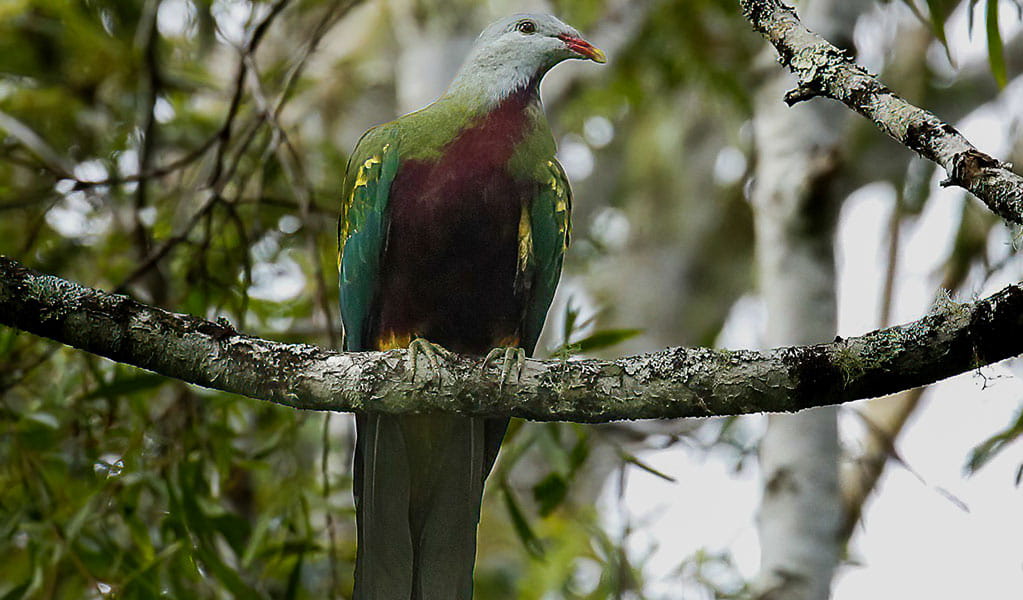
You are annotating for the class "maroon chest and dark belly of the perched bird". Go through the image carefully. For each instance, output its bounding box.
[371,87,535,354]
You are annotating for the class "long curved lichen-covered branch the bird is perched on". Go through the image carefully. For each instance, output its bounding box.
[0,257,1023,423]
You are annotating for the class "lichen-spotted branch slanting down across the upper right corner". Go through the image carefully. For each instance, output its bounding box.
[739,0,1023,223]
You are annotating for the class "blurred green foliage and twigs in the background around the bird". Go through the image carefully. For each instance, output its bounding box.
[0,0,1016,600]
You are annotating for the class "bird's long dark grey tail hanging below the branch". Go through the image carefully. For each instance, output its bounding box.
[355,415,506,600]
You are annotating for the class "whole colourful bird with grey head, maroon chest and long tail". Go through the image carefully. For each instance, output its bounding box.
[339,14,605,600]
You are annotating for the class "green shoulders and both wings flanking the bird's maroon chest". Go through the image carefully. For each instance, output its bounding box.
[338,97,572,354]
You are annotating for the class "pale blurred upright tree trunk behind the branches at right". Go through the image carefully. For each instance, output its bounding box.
[752,0,866,600]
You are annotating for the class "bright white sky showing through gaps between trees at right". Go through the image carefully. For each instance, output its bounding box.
[601,3,1023,600]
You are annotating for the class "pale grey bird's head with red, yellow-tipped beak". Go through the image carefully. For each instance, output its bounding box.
[452,14,607,105]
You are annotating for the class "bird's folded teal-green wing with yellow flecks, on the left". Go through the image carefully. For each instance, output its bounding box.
[338,126,398,351]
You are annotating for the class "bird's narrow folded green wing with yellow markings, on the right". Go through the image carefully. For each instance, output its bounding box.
[520,160,572,355]
